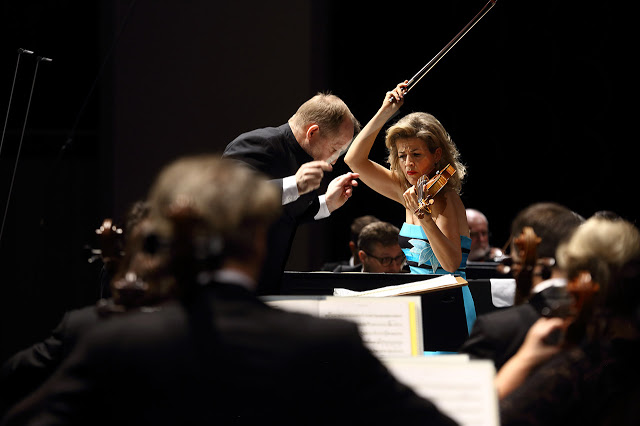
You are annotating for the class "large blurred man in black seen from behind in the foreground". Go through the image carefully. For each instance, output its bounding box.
[4,156,455,425]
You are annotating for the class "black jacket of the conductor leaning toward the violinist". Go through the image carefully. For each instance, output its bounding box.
[223,124,320,294]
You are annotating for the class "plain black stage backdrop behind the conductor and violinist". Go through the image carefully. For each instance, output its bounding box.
[0,0,637,359]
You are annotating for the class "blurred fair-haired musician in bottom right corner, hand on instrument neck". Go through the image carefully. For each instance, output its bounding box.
[495,218,640,426]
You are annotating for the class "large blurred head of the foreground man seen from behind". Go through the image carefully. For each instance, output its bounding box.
[149,156,281,290]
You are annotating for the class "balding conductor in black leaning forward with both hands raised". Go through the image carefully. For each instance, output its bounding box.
[223,94,360,294]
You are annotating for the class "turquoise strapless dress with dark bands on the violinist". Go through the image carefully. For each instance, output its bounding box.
[398,222,476,333]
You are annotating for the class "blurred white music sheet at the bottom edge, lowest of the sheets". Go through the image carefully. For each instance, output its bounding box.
[382,355,500,426]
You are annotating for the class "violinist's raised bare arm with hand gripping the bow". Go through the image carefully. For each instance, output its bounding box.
[344,82,406,205]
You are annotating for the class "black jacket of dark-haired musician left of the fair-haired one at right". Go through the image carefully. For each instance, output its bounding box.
[460,303,540,370]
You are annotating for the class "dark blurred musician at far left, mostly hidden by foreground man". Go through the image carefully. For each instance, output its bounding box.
[0,201,174,418]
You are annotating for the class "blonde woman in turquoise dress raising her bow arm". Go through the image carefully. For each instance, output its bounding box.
[344,81,475,327]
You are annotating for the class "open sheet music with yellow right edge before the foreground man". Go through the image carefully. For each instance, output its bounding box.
[263,296,424,357]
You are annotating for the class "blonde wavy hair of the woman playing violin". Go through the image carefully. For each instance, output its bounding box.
[385,112,467,194]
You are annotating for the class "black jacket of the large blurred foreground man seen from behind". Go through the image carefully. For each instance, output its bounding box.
[6,284,454,425]
